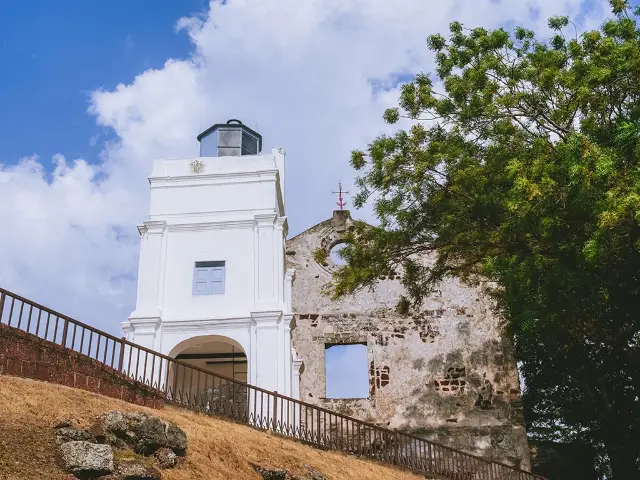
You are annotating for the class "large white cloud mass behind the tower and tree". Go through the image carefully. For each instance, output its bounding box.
[0,0,602,333]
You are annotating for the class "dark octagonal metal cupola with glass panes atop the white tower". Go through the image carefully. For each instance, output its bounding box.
[198,119,262,157]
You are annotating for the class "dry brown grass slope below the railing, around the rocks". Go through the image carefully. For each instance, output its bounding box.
[0,375,421,480]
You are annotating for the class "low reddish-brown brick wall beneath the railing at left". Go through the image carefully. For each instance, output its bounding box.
[0,324,164,408]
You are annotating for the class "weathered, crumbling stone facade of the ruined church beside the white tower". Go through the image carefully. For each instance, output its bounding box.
[286,211,530,469]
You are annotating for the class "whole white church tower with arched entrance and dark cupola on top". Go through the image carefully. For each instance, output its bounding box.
[122,120,298,397]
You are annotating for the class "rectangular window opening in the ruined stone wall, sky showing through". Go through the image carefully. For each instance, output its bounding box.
[325,343,369,399]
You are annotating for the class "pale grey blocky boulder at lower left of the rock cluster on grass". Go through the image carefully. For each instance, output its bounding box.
[60,441,113,478]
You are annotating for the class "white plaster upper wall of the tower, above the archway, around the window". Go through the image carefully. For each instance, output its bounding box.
[131,149,290,321]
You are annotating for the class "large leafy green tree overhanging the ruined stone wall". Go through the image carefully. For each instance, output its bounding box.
[331,0,640,479]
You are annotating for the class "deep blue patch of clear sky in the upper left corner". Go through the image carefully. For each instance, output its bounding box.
[0,0,202,167]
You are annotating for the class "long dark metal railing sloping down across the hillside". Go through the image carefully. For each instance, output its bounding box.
[0,288,545,480]
